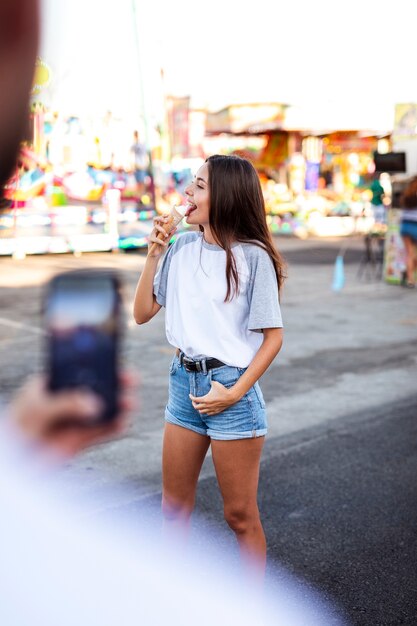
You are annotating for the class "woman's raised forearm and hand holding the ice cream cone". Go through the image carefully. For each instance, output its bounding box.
[133,217,175,324]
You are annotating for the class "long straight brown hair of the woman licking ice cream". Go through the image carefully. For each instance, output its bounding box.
[206,154,285,301]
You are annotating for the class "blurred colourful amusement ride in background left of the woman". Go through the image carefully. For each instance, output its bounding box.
[0,59,182,257]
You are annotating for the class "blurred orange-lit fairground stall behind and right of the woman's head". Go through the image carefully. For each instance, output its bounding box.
[207,103,389,237]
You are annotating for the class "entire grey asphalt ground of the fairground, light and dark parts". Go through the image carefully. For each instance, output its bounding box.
[0,238,417,626]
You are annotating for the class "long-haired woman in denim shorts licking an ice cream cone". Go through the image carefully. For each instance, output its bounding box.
[134,155,284,572]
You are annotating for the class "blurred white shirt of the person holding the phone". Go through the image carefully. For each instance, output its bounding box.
[0,429,342,626]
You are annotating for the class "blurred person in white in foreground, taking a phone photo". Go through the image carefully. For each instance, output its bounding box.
[0,0,348,626]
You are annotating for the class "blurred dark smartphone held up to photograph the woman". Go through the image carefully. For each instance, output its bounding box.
[44,270,122,422]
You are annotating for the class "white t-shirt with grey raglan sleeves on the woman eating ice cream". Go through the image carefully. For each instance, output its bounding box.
[154,232,282,368]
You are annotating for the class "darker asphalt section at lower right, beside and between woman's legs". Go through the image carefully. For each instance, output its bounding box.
[193,394,417,626]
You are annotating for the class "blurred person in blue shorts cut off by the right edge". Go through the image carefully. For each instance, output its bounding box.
[400,176,417,288]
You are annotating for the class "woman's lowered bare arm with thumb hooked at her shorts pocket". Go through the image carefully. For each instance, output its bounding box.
[190,328,283,415]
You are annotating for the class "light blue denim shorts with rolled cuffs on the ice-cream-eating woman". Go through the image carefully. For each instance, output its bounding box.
[165,356,267,440]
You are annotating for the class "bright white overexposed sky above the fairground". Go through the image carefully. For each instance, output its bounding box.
[41,0,417,128]
